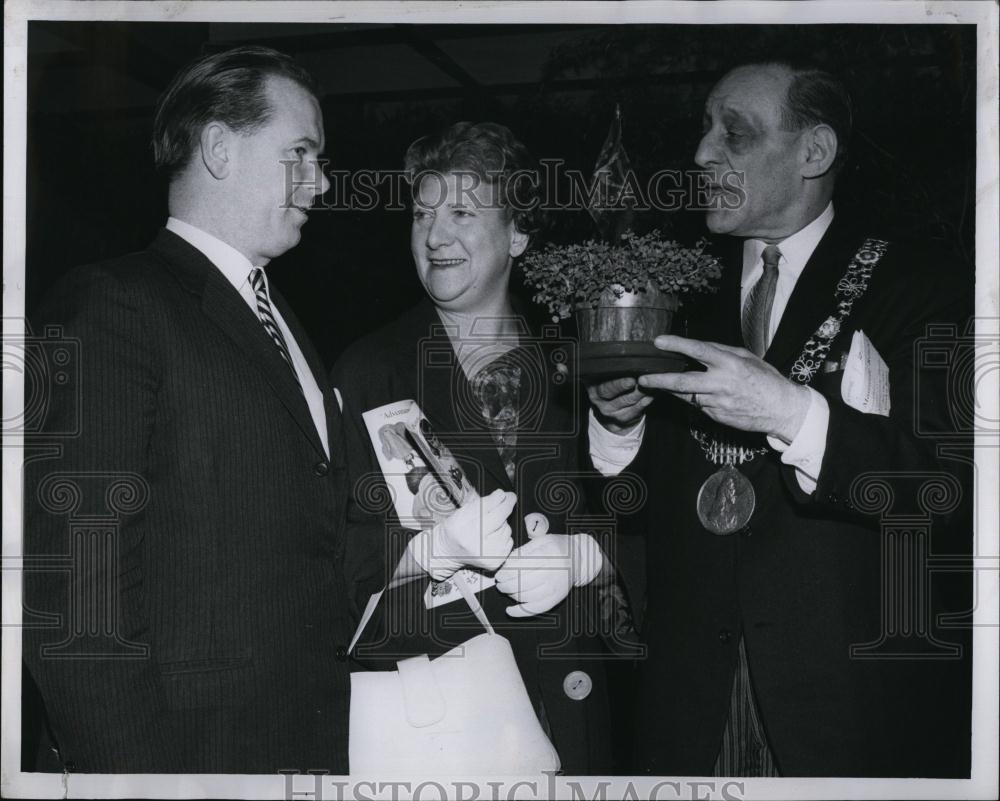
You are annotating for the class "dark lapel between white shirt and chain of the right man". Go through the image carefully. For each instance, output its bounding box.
[764,219,855,374]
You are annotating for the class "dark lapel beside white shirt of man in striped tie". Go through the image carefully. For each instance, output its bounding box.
[150,230,326,457]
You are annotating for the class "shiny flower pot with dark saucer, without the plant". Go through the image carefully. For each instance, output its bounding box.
[576,284,685,379]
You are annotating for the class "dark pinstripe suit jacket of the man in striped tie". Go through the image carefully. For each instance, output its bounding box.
[24,231,358,773]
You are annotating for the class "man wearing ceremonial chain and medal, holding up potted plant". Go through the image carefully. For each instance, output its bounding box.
[589,63,972,777]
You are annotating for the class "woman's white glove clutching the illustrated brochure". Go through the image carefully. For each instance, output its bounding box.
[407,489,517,581]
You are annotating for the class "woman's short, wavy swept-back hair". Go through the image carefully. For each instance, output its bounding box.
[403,122,544,236]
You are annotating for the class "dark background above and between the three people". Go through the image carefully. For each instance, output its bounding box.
[27,21,976,363]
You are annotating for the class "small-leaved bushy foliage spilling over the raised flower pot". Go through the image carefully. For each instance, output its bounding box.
[522,231,722,322]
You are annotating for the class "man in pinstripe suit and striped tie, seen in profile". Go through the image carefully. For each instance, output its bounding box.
[24,47,351,773]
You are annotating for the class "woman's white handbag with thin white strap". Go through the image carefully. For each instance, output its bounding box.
[348,581,559,776]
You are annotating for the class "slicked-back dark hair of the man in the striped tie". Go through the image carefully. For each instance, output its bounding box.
[153,46,318,176]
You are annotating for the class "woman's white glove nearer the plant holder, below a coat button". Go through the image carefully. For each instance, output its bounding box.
[496,514,604,617]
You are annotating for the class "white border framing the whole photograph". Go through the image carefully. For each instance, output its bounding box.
[0,0,1000,801]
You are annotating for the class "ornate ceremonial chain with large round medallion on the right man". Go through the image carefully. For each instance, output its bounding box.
[690,239,889,535]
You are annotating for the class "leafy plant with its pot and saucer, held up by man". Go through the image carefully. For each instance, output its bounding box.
[523,231,721,378]
